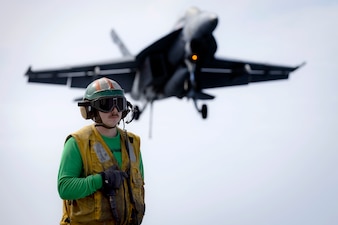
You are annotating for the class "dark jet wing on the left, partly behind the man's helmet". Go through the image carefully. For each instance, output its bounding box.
[26,57,137,93]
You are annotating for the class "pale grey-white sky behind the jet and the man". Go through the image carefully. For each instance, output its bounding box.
[0,0,338,225]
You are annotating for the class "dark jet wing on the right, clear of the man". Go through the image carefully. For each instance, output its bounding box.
[196,59,304,89]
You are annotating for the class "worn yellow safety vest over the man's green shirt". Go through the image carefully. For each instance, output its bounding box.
[60,124,145,225]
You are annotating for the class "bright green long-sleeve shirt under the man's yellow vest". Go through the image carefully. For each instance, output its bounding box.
[58,133,144,200]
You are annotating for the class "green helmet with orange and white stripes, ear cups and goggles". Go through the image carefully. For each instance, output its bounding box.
[78,77,131,123]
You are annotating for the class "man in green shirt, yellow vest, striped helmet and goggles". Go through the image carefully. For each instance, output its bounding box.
[58,77,145,225]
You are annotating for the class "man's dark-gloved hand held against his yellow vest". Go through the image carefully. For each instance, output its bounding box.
[101,165,128,192]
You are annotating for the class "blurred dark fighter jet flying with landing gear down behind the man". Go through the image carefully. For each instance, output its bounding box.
[26,7,303,119]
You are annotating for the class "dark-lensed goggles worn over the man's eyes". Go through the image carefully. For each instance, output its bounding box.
[91,97,127,112]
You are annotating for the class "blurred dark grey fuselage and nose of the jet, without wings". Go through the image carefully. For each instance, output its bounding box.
[131,8,218,101]
